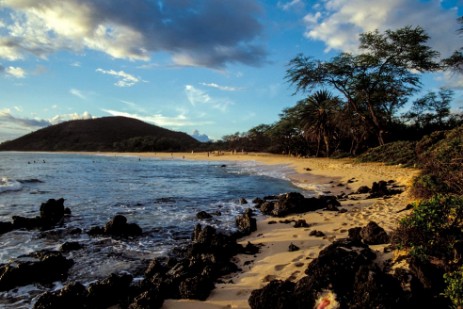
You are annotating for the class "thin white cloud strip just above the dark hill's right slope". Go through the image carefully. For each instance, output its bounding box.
[103,109,213,128]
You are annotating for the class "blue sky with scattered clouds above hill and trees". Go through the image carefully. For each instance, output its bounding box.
[0,0,463,142]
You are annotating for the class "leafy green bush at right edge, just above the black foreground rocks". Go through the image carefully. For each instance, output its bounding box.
[394,195,463,261]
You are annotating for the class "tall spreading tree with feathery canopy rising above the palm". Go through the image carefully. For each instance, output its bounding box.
[286,27,439,145]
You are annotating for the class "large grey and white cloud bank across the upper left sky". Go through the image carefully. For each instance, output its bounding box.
[0,0,266,68]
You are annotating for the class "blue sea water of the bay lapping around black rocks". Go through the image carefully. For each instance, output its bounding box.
[0,152,310,308]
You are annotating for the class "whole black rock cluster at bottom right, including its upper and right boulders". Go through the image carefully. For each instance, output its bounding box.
[248,222,448,309]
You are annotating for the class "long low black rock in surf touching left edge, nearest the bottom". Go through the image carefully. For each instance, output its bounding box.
[0,251,73,291]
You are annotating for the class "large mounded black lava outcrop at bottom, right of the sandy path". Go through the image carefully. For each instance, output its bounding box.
[248,239,405,309]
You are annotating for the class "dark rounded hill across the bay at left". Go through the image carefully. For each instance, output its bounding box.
[0,117,199,151]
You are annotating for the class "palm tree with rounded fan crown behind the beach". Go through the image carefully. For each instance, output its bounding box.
[298,90,341,157]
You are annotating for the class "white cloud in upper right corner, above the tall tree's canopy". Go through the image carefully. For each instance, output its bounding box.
[304,0,461,57]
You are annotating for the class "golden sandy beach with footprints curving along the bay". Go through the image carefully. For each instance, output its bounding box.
[107,153,419,309]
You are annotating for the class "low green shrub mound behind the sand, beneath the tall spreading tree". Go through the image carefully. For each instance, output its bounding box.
[357,141,417,166]
